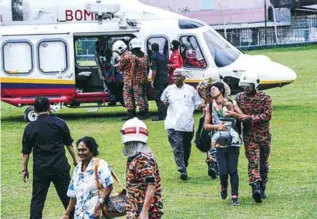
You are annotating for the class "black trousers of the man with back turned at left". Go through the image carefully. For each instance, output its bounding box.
[30,171,74,219]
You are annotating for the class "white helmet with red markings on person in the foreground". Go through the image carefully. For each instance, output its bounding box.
[121,117,148,144]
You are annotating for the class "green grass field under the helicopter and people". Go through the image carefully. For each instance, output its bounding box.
[1,46,317,219]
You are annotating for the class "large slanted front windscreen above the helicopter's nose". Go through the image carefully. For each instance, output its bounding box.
[204,30,241,67]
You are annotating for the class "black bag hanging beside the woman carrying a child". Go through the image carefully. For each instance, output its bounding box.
[195,116,211,153]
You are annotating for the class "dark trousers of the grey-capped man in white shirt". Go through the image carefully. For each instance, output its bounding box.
[167,129,194,173]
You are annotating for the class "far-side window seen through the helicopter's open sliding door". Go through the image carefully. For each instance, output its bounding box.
[75,38,98,67]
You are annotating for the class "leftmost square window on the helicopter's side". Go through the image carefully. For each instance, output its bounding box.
[2,41,33,74]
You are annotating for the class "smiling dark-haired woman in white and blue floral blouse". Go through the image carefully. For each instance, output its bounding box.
[62,137,112,219]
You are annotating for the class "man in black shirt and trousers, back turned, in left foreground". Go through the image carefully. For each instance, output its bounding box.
[22,97,77,219]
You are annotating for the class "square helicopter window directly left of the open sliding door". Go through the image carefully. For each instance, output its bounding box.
[38,40,68,73]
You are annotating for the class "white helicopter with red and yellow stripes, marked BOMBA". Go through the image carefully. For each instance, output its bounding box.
[0,0,296,121]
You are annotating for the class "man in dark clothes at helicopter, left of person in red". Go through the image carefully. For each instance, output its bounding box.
[151,43,168,121]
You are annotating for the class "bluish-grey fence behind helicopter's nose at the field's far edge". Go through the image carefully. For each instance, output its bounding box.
[218,13,317,48]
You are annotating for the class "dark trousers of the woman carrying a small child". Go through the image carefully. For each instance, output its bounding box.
[217,147,240,195]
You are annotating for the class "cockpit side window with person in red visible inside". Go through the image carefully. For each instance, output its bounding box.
[179,35,207,68]
